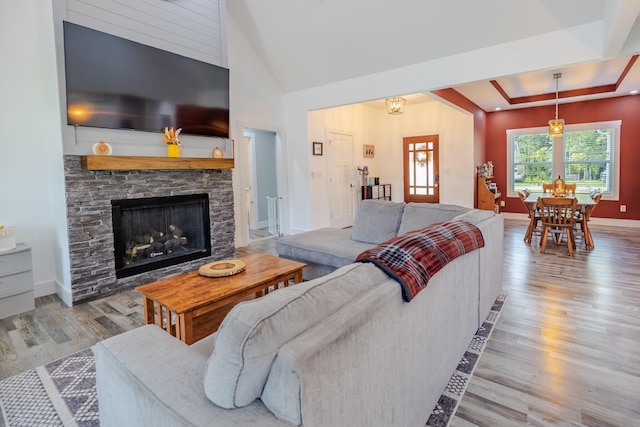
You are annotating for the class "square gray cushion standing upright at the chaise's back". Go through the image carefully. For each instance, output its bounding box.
[352,200,404,244]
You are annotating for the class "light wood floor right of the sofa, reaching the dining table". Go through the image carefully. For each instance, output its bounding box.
[452,220,640,427]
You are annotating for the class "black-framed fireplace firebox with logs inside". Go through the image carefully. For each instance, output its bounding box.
[111,194,211,278]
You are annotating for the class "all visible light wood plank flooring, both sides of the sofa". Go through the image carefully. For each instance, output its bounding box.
[0,219,640,427]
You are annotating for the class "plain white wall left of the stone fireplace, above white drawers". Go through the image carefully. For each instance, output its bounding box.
[0,0,66,300]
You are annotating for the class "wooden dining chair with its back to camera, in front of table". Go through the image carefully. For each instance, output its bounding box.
[538,197,578,256]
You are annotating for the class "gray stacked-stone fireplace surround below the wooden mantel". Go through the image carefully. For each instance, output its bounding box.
[64,155,235,304]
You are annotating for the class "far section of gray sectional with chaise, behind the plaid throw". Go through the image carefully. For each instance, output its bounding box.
[276,200,504,322]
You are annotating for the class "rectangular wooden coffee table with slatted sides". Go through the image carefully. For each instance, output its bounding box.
[136,254,306,344]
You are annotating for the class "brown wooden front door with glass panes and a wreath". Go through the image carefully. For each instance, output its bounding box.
[403,135,440,203]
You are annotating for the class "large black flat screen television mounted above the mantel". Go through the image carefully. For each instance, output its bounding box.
[64,22,229,138]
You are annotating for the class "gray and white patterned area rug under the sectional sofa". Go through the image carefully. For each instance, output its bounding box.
[0,293,507,427]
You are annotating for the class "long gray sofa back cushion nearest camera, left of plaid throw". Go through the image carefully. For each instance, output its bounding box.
[204,264,388,409]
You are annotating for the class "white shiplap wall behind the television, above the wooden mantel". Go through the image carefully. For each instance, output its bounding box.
[54,0,230,157]
